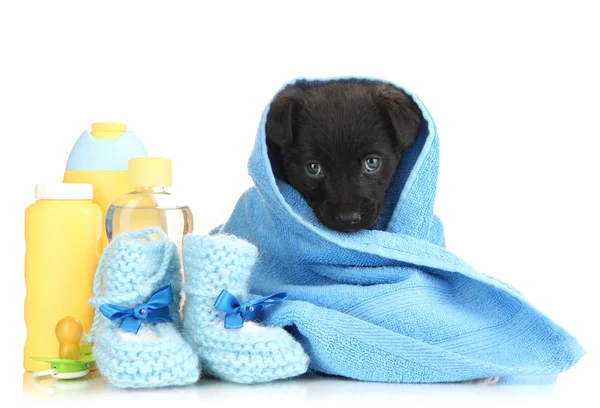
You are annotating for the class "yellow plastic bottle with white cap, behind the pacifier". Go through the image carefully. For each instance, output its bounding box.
[23,184,103,371]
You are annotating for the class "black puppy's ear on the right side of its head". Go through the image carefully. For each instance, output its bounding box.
[374,83,423,151]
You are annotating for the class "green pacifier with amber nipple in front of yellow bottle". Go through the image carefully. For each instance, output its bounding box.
[31,316,94,380]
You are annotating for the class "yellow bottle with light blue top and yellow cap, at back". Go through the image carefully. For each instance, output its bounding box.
[64,122,148,251]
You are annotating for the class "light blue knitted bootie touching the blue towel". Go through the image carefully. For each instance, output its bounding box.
[183,234,309,384]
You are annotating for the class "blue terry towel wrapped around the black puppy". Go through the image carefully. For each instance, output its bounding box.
[213,78,585,383]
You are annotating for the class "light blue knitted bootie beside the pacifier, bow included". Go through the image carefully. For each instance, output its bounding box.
[90,229,200,388]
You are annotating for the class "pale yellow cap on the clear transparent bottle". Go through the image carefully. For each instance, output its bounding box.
[128,157,173,188]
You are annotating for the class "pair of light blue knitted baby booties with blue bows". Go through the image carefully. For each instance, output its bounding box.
[89,228,309,388]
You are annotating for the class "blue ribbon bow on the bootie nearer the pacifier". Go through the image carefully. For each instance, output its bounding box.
[100,285,173,334]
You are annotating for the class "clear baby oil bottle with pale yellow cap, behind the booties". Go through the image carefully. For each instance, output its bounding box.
[106,157,194,250]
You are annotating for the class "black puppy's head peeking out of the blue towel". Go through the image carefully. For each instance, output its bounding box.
[266,81,422,232]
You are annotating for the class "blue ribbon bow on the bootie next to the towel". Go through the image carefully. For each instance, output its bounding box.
[215,289,287,329]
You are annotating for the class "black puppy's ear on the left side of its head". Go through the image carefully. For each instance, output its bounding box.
[267,85,303,147]
